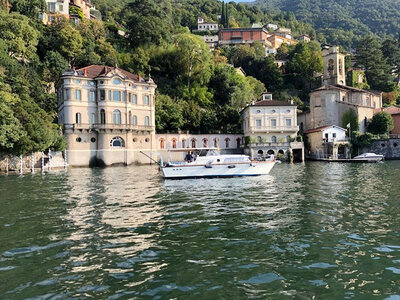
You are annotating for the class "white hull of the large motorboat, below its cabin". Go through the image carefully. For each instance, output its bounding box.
[161,161,275,179]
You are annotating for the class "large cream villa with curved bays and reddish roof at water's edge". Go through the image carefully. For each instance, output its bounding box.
[57,65,156,166]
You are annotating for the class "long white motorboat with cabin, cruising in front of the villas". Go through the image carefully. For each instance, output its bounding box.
[161,148,275,179]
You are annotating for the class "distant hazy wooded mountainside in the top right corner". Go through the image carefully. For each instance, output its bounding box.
[249,0,400,49]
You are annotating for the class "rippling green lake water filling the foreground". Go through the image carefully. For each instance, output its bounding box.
[0,161,400,300]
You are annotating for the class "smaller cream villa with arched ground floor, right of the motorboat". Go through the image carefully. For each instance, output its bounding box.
[241,92,304,160]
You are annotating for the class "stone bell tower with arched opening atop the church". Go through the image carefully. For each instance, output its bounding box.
[322,46,346,85]
